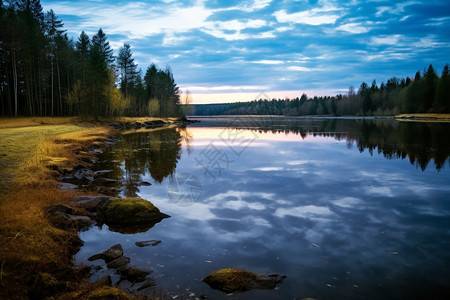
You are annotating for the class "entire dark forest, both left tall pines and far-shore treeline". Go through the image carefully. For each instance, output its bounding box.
[0,0,450,119]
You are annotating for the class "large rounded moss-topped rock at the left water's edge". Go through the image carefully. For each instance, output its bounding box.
[105,198,170,225]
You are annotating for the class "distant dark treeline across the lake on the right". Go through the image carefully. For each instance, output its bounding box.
[188,64,450,116]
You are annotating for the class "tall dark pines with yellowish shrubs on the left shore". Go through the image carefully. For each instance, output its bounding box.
[0,0,182,118]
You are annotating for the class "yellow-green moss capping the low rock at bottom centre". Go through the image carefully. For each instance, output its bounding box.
[203,268,258,293]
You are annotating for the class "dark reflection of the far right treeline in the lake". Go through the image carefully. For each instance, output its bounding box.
[189,116,450,170]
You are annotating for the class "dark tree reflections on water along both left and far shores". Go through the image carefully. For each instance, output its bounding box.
[95,117,450,197]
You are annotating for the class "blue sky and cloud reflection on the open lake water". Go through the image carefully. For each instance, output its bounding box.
[78,119,450,299]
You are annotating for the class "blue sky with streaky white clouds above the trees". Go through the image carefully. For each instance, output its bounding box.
[41,0,450,103]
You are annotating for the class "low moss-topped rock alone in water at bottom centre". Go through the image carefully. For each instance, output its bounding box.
[203,269,286,293]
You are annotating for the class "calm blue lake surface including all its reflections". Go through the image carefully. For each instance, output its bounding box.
[76,116,450,299]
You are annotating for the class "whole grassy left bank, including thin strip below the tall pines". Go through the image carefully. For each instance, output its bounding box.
[0,118,176,299]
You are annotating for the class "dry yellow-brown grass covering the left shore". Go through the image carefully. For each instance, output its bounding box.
[0,123,112,299]
